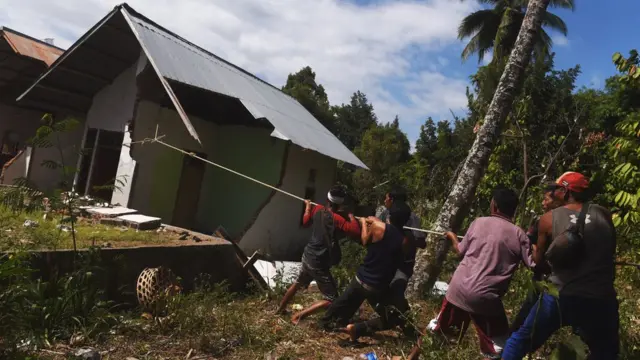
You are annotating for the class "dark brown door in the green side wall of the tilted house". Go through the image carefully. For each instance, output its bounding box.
[172,153,207,229]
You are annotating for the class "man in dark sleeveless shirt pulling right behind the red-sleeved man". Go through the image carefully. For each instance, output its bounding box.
[320,203,411,338]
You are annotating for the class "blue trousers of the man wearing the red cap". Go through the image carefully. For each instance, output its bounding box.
[502,294,619,360]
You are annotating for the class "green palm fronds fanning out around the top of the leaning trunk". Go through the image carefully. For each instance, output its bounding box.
[458,0,574,62]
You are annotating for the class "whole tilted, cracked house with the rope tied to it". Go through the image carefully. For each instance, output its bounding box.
[13,4,366,260]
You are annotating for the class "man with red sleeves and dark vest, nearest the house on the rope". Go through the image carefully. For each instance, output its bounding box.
[276,186,360,324]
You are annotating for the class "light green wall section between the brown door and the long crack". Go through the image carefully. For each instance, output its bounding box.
[197,126,286,237]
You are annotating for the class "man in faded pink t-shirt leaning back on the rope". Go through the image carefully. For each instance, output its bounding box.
[409,188,533,359]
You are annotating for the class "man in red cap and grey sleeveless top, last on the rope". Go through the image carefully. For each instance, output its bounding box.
[502,172,619,360]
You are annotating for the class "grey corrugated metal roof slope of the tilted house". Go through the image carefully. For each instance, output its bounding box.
[122,6,367,168]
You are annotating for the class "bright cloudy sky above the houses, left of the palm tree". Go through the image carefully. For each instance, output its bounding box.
[0,0,477,141]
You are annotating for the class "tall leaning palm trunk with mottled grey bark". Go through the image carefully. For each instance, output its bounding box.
[408,0,549,297]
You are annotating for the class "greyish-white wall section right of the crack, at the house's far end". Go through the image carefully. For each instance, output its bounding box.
[239,145,337,261]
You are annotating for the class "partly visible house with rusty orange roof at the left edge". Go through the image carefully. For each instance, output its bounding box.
[0,27,64,184]
